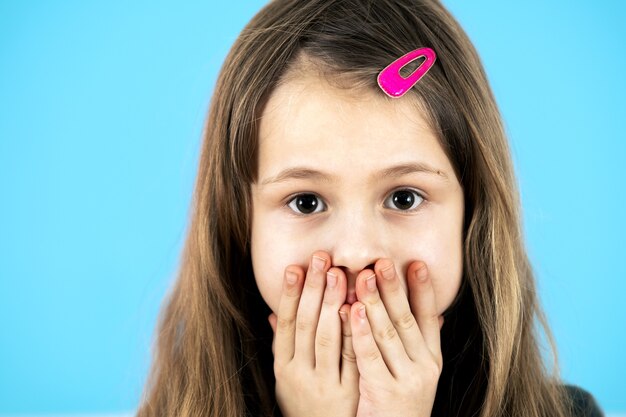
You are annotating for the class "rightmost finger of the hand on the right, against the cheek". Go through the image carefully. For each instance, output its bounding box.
[407,262,441,357]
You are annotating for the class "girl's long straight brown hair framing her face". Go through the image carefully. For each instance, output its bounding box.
[138,0,567,417]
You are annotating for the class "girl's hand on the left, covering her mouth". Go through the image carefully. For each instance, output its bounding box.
[269,252,359,417]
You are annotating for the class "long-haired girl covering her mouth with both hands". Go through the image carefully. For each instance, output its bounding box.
[138,0,600,417]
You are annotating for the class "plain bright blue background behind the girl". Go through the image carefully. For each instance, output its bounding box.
[0,0,626,415]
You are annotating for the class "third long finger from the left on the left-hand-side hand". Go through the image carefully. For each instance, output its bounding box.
[315,268,347,380]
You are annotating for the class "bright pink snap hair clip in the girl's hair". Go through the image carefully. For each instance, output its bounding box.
[378,48,437,98]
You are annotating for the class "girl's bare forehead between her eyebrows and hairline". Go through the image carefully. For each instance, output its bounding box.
[258,73,452,177]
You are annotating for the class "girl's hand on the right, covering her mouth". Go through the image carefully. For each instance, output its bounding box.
[351,259,443,416]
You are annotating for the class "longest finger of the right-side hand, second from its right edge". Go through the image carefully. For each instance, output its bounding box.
[374,259,423,360]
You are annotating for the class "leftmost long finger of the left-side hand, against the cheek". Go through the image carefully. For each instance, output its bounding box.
[274,265,303,364]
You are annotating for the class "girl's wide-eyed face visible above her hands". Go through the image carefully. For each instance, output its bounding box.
[251,73,464,314]
